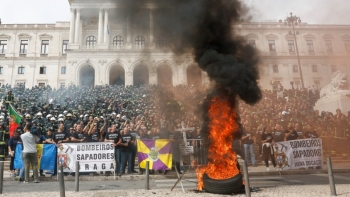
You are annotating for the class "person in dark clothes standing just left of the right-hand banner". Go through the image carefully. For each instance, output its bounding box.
[261,126,276,171]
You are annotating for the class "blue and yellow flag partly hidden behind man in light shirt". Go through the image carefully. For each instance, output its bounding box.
[14,144,56,170]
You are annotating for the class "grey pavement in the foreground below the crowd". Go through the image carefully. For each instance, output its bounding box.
[3,173,350,196]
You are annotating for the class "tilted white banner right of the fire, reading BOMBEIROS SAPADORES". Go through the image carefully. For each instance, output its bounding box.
[273,138,323,170]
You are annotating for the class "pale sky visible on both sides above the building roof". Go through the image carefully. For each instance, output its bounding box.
[0,0,350,24]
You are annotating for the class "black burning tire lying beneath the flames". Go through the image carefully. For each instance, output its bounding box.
[203,173,242,194]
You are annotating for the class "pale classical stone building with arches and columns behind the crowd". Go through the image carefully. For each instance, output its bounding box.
[0,0,350,88]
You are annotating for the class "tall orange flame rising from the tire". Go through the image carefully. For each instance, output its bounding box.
[196,96,240,190]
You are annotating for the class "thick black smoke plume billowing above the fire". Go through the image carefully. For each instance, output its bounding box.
[113,0,261,143]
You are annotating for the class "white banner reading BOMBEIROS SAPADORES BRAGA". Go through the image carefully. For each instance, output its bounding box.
[57,142,115,172]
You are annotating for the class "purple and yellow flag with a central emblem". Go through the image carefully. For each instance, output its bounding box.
[137,139,172,170]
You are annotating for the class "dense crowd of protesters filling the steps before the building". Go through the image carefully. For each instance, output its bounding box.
[0,84,350,181]
